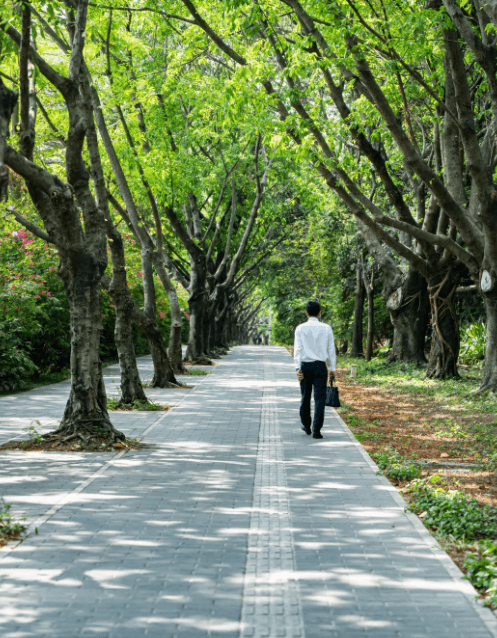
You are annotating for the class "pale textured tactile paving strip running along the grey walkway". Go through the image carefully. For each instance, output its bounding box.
[241,356,305,638]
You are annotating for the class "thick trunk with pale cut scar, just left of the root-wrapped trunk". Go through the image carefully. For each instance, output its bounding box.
[387,268,429,365]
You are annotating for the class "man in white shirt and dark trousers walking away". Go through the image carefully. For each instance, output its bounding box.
[293,301,336,439]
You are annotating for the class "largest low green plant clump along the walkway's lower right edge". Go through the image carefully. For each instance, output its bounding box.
[408,475,497,540]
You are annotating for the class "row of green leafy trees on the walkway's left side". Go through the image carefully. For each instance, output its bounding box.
[0,0,291,448]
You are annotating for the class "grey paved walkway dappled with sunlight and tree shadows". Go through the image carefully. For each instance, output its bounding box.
[0,346,497,638]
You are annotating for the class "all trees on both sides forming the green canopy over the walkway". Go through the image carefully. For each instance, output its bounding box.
[4,0,497,444]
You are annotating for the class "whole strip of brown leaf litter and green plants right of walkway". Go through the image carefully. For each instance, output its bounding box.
[337,357,497,609]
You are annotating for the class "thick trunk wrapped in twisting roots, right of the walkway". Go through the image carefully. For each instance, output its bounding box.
[426,268,461,379]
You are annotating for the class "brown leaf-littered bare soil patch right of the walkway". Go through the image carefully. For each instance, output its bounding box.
[336,368,497,505]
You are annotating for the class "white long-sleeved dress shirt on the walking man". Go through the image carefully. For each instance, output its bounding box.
[293,317,336,372]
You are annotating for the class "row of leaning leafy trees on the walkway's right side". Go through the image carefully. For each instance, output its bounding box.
[170,0,497,391]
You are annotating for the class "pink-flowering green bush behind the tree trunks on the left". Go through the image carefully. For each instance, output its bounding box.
[0,228,188,392]
